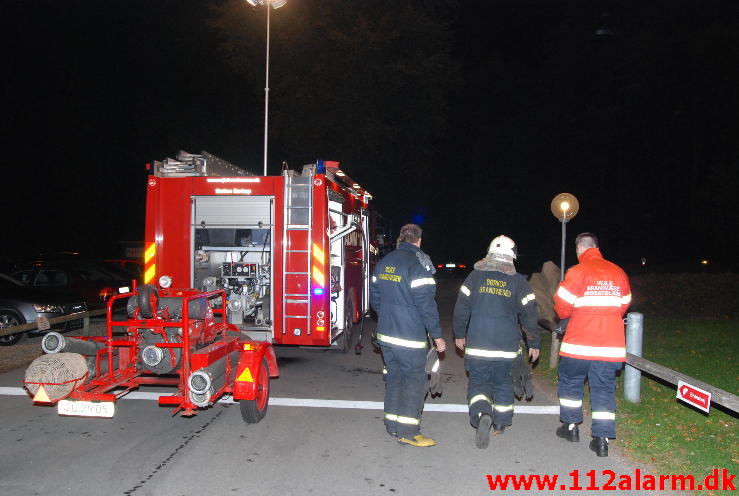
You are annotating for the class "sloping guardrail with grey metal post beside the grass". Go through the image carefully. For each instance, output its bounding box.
[624,312,739,413]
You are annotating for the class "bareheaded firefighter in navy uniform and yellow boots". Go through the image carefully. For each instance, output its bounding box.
[370,224,446,446]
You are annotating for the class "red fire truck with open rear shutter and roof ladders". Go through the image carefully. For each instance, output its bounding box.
[144,152,382,351]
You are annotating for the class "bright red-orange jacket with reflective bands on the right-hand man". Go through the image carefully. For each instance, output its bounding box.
[554,248,631,362]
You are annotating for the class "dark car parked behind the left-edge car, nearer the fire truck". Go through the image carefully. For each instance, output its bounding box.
[11,258,134,308]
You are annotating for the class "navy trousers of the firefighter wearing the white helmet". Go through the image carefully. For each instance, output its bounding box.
[466,358,513,428]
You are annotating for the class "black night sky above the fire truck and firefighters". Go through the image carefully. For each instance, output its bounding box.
[5,0,739,273]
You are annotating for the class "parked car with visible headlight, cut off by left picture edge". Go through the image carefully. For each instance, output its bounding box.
[0,273,87,346]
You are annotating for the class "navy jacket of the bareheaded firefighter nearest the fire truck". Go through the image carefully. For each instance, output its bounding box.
[370,243,441,348]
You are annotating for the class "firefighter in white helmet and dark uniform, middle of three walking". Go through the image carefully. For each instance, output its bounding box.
[454,236,539,448]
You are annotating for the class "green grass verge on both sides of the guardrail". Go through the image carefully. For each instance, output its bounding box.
[537,318,739,494]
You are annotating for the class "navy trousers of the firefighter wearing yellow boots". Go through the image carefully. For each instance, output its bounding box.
[380,344,427,438]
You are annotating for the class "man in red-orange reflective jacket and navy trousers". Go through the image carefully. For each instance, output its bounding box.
[554,233,631,456]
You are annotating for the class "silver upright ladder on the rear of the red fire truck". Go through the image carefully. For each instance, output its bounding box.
[282,167,313,335]
